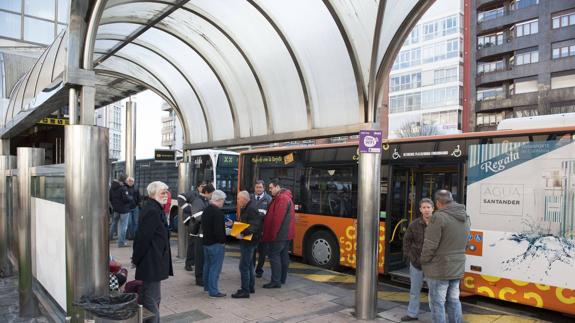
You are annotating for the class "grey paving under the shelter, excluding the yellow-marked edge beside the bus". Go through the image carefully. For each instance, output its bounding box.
[110,241,405,323]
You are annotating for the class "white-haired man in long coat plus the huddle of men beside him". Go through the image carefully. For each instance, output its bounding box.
[128,180,295,322]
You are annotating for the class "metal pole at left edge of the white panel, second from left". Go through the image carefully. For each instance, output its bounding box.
[15,147,44,317]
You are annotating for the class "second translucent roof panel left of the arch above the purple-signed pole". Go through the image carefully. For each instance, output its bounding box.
[185,0,311,133]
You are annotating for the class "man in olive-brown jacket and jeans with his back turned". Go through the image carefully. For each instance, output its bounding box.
[421,190,470,323]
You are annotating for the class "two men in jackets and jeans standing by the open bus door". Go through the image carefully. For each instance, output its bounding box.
[401,190,470,323]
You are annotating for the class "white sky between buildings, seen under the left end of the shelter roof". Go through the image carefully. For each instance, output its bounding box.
[120,90,168,160]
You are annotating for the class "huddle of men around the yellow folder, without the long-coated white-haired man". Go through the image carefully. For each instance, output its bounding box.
[178,180,295,298]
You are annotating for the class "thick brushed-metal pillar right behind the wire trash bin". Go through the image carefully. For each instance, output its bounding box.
[64,125,109,322]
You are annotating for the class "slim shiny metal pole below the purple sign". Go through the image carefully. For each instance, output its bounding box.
[355,149,381,320]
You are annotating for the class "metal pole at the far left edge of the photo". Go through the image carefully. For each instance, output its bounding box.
[0,155,16,277]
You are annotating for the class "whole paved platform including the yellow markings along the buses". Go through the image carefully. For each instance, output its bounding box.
[110,240,542,323]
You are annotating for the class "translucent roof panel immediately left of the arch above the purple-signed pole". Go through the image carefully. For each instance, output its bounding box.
[258,0,363,128]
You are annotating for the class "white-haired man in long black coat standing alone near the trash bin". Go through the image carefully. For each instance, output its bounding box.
[132,181,174,322]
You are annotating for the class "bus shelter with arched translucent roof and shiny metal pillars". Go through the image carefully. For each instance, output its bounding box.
[0,0,433,321]
